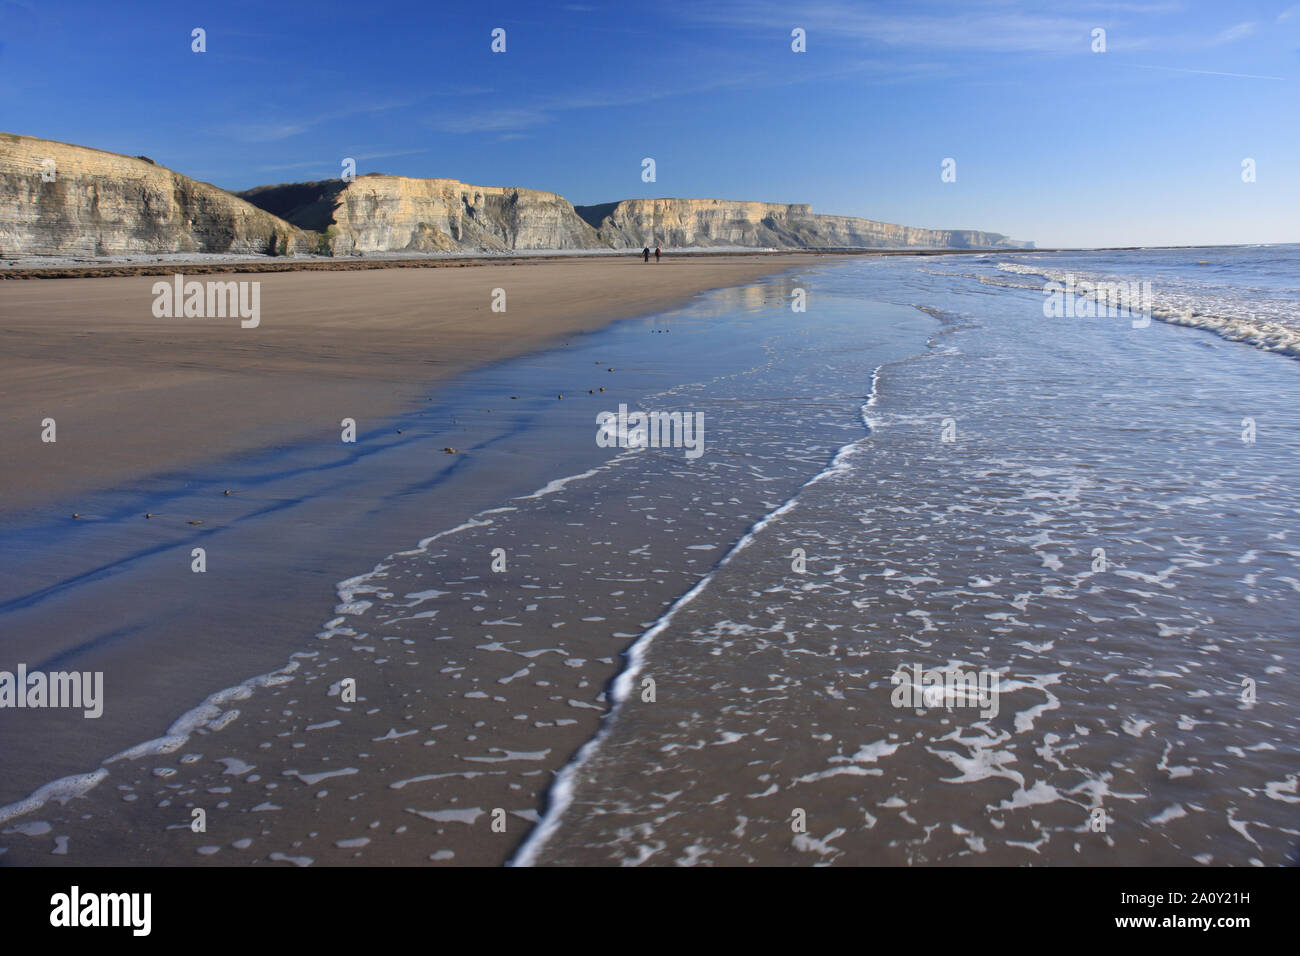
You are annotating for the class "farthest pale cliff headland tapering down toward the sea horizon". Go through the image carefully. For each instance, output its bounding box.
[577,199,1034,248]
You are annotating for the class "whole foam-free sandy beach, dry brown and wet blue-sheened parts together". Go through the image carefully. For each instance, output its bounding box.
[0,256,832,832]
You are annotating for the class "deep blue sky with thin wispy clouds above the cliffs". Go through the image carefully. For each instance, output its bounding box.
[0,0,1300,246]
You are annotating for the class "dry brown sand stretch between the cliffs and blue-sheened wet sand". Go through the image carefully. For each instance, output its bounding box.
[0,255,816,512]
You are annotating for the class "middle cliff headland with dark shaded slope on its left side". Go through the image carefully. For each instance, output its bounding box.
[239,174,601,255]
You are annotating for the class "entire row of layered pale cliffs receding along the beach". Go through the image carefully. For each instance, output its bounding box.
[0,133,1034,258]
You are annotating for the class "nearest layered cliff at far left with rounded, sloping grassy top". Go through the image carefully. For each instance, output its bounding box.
[0,133,316,256]
